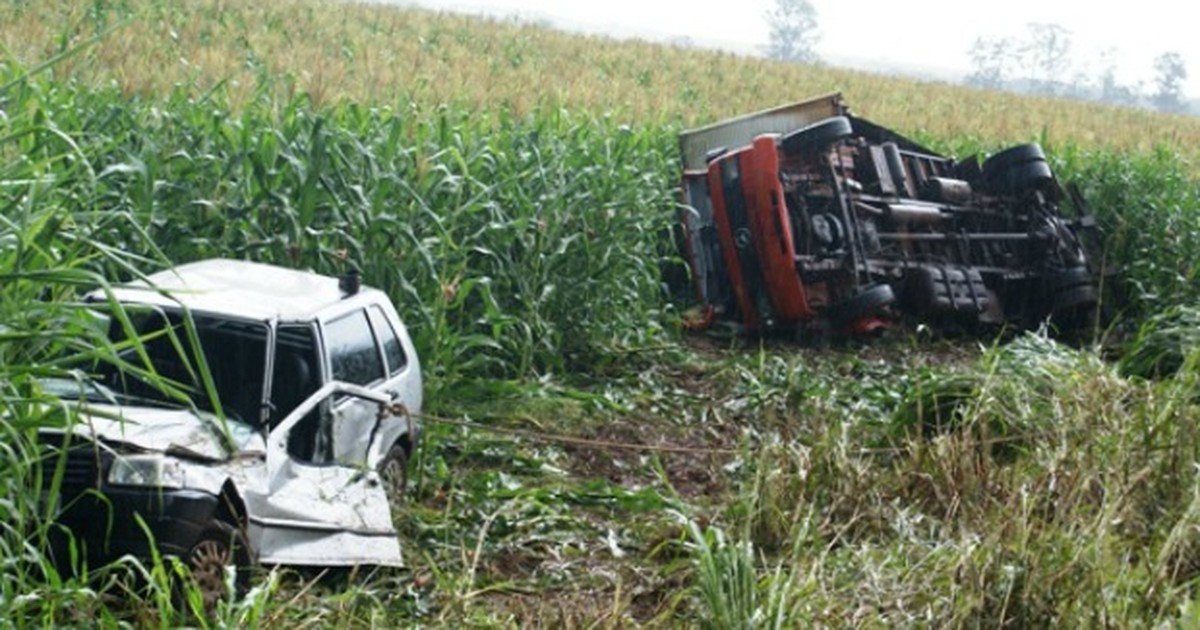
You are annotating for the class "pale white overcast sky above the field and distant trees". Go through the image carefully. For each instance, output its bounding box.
[373,0,1200,96]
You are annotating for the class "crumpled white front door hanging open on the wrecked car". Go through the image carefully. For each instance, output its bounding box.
[245,382,402,566]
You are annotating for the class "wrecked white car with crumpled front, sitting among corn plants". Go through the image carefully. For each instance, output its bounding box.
[40,260,421,599]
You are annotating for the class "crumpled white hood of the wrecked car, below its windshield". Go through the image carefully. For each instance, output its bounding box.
[72,404,266,461]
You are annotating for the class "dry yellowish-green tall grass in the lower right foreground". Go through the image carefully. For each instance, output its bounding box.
[691,336,1200,626]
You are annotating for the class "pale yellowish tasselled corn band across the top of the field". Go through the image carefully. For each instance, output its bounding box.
[7,0,1200,161]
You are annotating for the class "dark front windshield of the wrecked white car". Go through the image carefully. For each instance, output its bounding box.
[100,307,269,425]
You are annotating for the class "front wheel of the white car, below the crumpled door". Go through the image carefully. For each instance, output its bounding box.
[187,520,250,614]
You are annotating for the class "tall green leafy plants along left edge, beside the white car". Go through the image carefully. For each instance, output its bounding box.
[0,57,152,625]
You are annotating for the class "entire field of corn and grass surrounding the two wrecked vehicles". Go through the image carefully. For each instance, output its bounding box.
[7,0,1200,628]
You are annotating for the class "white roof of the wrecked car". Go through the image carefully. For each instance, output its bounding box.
[99,258,374,322]
